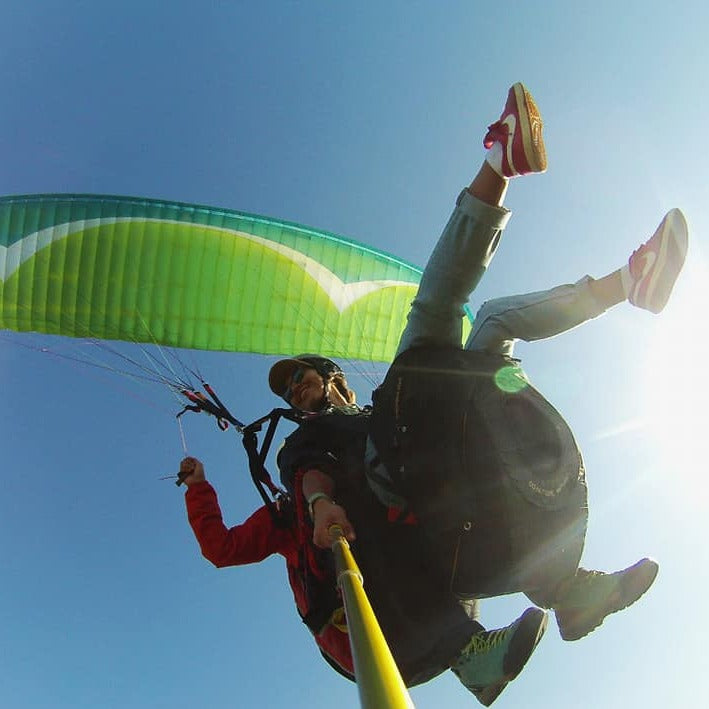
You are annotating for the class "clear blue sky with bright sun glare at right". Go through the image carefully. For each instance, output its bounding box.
[0,0,709,709]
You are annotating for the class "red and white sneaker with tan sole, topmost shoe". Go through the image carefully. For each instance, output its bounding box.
[483,82,547,177]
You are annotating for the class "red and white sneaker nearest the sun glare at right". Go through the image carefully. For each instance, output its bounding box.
[621,209,689,313]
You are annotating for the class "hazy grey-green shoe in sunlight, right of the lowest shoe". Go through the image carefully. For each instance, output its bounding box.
[554,559,659,640]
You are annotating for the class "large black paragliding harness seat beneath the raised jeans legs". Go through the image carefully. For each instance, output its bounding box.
[367,348,587,597]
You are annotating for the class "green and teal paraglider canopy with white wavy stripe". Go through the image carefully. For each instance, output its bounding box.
[0,195,436,361]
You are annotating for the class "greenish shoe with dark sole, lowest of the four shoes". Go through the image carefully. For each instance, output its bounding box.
[451,608,547,707]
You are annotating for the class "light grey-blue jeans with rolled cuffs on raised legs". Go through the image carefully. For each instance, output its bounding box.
[397,190,605,356]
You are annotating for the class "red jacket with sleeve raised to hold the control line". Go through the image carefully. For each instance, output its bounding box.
[185,481,354,676]
